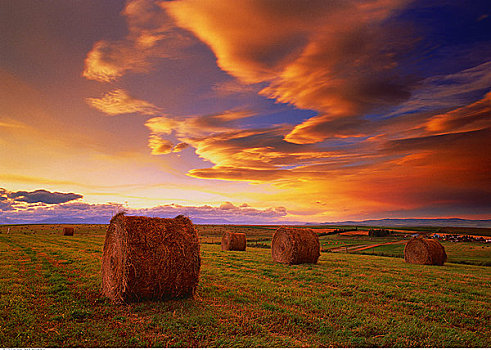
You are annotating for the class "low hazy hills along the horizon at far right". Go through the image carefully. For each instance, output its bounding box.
[321,218,491,228]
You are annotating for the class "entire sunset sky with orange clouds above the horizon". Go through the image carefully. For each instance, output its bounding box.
[0,0,491,224]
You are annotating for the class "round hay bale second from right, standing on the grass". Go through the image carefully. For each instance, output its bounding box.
[271,227,320,265]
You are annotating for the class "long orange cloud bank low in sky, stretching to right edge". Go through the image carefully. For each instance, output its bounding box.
[147,97,491,218]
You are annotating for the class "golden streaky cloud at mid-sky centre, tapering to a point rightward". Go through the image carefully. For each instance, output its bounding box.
[145,111,340,169]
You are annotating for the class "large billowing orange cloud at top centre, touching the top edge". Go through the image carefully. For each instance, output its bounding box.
[161,0,412,143]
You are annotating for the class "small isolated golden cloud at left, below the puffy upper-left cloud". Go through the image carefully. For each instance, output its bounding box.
[86,89,160,115]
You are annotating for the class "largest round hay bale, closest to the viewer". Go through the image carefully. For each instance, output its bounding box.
[102,213,201,302]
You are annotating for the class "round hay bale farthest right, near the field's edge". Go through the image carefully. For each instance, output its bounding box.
[404,237,447,266]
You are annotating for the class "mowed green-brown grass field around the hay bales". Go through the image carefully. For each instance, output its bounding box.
[0,234,491,347]
